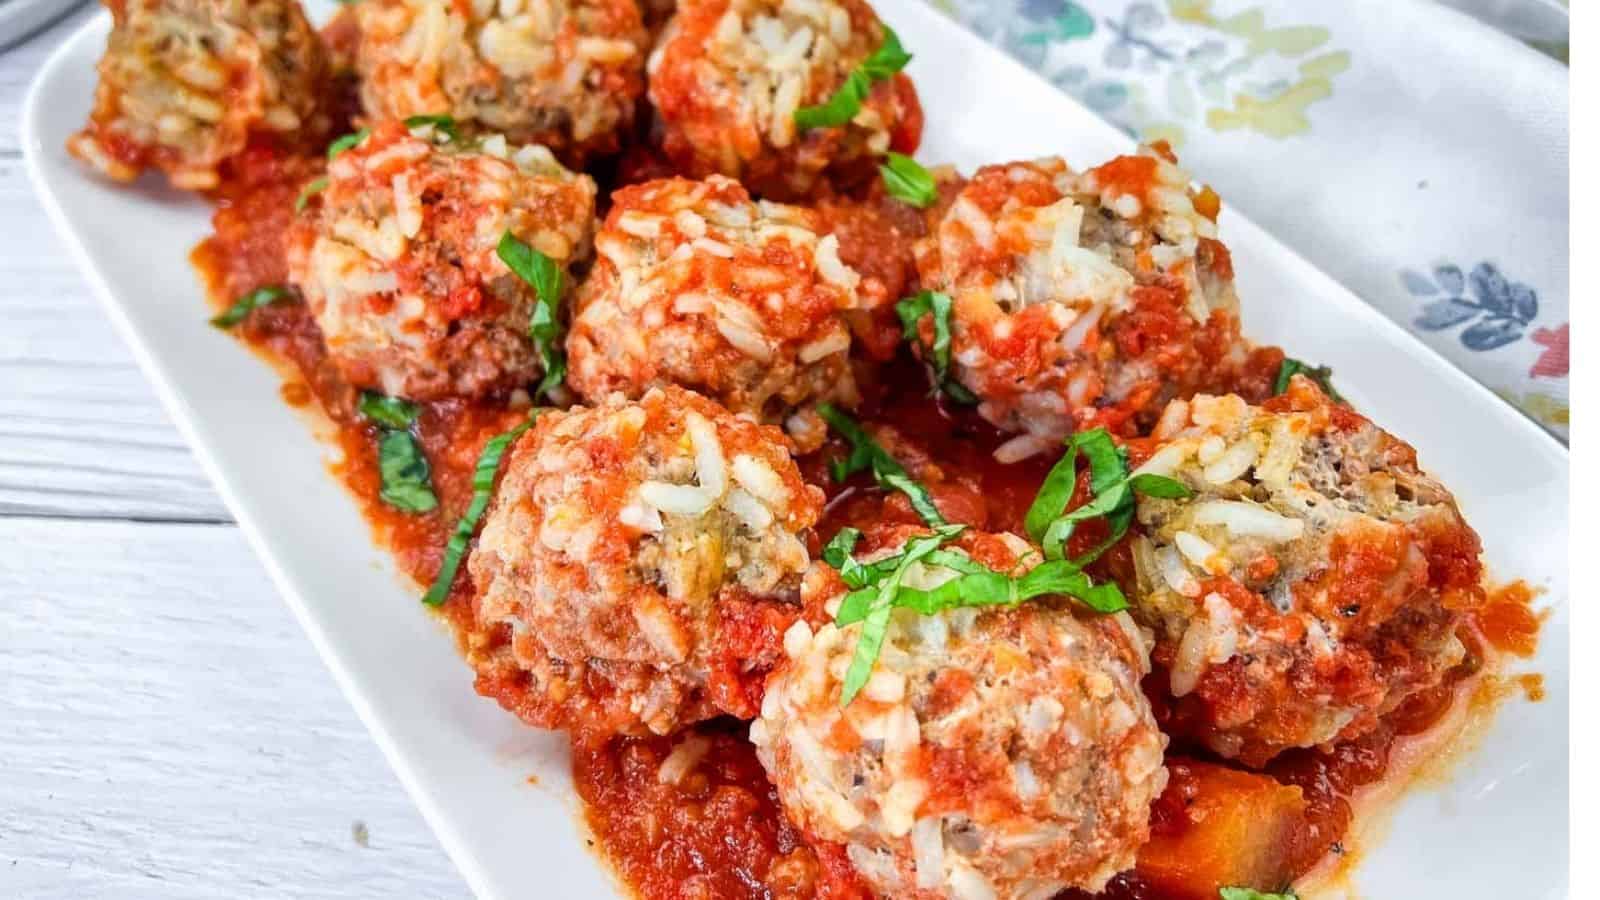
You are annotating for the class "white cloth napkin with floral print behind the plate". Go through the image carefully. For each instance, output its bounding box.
[931,0,1568,440]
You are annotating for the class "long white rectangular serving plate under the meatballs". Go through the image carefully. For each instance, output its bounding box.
[22,0,1568,900]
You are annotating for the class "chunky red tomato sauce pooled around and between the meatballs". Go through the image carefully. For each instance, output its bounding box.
[190,152,1539,900]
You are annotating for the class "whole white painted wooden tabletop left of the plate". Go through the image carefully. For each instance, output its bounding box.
[0,10,467,900]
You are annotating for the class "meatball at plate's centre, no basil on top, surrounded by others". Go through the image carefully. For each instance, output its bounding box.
[566,175,861,447]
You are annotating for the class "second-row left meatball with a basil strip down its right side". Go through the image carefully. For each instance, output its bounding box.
[288,122,595,400]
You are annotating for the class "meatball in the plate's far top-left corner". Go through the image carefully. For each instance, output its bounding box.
[67,0,326,191]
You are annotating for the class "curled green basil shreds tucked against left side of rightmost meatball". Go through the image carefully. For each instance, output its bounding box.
[1022,428,1194,567]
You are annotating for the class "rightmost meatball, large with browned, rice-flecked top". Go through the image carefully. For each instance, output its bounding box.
[1125,376,1483,765]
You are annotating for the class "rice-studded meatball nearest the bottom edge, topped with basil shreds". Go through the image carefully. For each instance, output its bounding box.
[750,525,1166,900]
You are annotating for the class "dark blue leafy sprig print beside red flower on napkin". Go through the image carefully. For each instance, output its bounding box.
[1400,263,1539,352]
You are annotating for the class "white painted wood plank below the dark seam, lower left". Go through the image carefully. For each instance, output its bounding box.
[0,519,472,900]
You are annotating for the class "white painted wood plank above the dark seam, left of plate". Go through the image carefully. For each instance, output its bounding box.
[0,24,232,520]
